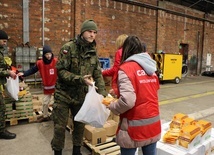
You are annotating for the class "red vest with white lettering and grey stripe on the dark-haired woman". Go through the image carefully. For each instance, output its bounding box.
[120,62,161,141]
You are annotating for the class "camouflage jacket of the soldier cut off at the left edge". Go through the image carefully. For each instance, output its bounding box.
[0,47,10,85]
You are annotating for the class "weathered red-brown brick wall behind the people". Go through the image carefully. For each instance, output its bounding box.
[0,0,214,74]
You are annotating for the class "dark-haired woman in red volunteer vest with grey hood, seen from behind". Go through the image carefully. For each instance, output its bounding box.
[108,36,161,155]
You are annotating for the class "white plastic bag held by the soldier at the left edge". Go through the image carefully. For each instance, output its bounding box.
[6,77,19,101]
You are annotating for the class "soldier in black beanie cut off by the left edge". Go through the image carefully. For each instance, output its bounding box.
[0,30,17,139]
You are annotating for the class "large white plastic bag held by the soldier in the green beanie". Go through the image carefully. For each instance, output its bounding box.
[74,83,110,128]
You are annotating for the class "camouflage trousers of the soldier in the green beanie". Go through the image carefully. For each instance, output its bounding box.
[51,98,85,150]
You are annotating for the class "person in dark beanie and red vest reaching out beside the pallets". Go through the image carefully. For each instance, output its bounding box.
[18,45,57,122]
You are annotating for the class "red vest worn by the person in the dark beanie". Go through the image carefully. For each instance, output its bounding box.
[36,58,57,94]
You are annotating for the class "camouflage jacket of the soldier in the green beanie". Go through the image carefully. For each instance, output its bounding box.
[56,37,107,102]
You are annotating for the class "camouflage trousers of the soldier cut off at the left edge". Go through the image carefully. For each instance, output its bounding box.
[0,92,6,132]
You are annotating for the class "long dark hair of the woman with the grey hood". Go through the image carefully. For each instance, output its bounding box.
[121,36,145,64]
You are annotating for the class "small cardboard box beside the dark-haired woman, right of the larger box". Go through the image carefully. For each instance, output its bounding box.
[103,120,118,136]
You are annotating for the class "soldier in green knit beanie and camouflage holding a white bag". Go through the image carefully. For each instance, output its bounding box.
[51,20,107,155]
